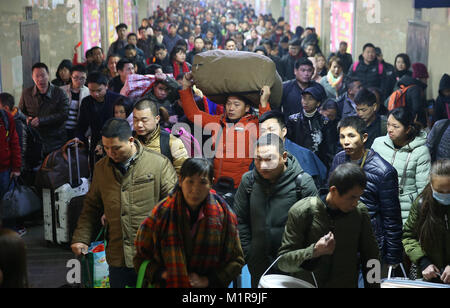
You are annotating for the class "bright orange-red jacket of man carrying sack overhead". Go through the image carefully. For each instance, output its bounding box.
[179,89,270,188]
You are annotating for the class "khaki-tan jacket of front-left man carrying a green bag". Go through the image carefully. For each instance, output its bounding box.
[72,141,177,268]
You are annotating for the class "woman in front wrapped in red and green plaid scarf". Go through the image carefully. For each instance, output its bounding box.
[134,158,244,288]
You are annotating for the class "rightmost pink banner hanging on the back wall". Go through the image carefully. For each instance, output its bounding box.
[330,1,354,53]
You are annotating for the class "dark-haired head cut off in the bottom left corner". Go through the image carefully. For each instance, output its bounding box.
[0,229,28,288]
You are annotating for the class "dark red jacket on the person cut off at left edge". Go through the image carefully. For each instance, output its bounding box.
[0,110,22,172]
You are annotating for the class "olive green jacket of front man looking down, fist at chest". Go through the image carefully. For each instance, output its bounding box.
[278,197,380,288]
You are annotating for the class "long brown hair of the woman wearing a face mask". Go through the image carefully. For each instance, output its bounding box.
[415,159,450,253]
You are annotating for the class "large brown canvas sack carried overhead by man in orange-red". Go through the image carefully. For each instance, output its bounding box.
[192,50,283,109]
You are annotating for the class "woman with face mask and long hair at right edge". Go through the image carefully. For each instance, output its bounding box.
[403,159,450,284]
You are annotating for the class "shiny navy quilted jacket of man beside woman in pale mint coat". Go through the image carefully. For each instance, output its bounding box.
[330,150,403,264]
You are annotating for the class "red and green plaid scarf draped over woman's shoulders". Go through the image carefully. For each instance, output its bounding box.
[135,189,240,288]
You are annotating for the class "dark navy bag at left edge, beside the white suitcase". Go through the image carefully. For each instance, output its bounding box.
[0,178,42,219]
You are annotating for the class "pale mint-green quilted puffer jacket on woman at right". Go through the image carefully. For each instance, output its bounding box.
[372,132,431,224]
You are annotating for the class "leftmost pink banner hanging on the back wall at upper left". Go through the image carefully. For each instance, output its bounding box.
[83,0,102,55]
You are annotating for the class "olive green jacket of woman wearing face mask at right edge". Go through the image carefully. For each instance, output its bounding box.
[402,192,450,278]
